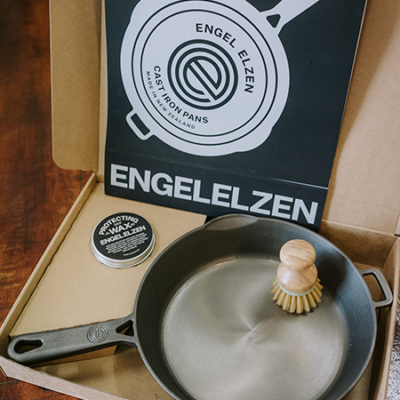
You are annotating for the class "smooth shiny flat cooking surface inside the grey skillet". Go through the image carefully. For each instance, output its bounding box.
[161,257,348,400]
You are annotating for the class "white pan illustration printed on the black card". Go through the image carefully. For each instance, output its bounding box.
[120,0,319,156]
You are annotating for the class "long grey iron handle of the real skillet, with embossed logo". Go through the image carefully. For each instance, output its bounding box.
[7,314,137,365]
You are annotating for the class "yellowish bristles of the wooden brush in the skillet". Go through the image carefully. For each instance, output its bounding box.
[272,279,323,314]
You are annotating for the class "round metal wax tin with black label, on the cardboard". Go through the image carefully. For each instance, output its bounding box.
[92,212,155,268]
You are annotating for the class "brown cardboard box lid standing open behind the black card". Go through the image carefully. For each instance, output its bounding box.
[51,0,400,234]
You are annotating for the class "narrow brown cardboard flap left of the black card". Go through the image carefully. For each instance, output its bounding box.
[50,0,101,171]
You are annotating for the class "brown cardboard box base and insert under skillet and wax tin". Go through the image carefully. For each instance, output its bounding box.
[0,179,399,400]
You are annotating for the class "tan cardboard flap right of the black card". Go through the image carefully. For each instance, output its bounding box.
[323,0,400,234]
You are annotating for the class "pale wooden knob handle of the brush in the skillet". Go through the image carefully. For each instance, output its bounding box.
[278,239,318,294]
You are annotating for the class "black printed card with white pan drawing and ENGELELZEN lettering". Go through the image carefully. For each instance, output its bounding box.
[105,0,365,230]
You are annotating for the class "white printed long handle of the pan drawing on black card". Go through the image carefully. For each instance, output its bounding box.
[262,0,319,33]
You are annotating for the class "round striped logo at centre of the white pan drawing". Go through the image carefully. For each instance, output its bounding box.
[168,40,238,110]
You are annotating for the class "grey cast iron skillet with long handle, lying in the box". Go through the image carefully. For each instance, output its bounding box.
[8,215,392,400]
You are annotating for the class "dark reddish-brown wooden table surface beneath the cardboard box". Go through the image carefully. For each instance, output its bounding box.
[0,0,400,400]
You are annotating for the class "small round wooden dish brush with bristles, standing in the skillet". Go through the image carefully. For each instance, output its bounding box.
[272,239,323,314]
